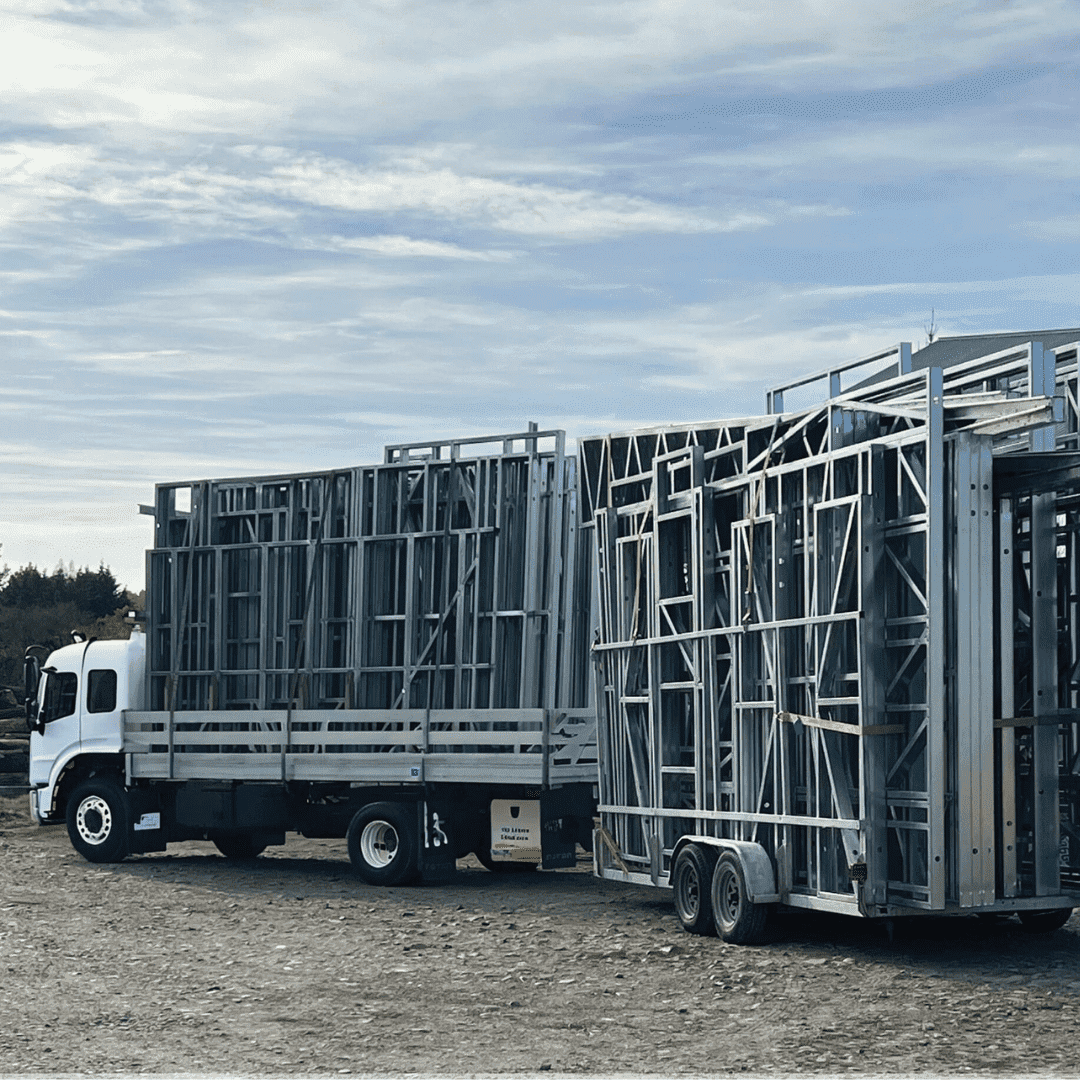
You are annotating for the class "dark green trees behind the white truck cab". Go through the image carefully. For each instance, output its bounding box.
[0,563,141,700]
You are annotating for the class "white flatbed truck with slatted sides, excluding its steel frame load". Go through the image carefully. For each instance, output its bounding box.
[28,629,596,885]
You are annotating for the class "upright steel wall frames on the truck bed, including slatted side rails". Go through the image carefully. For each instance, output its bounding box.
[138,426,596,780]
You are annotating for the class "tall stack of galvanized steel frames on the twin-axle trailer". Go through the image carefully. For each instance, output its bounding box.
[581,334,1080,915]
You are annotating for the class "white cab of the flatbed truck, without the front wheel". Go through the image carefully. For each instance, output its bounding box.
[27,629,146,822]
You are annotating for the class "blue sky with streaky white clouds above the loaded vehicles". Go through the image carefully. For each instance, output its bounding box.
[0,0,1080,591]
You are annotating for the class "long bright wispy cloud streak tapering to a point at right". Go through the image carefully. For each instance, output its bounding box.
[0,143,847,247]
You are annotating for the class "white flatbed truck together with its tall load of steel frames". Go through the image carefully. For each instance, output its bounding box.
[26,428,596,885]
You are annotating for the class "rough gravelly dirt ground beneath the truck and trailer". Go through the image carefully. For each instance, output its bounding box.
[0,798,1080,1077]
